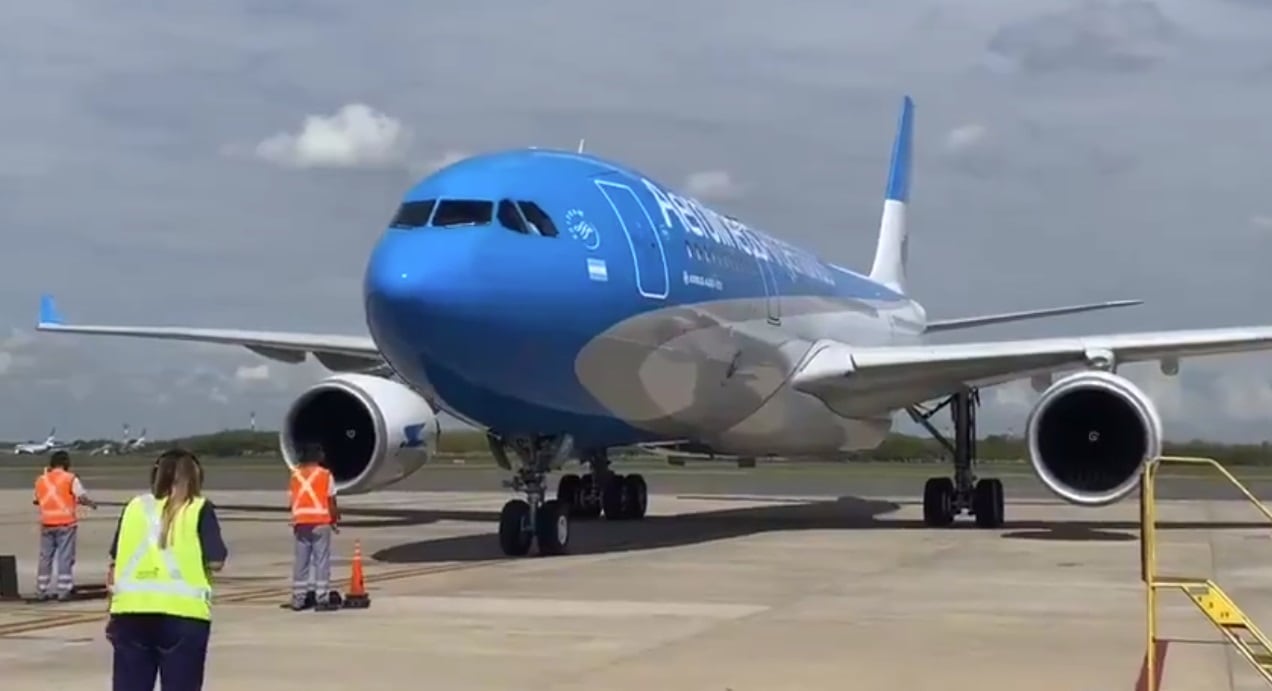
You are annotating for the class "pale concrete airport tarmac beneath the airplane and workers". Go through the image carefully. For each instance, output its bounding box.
[0,468,1272,691]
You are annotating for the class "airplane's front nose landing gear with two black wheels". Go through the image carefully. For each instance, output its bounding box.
[487,434,574,556]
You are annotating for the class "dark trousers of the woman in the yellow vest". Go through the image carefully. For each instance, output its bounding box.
[107,615,212,691]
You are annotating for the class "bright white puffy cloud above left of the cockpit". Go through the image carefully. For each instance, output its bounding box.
[254,103,413,168]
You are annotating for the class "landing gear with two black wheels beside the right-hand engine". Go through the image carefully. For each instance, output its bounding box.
[906,388,1004,528]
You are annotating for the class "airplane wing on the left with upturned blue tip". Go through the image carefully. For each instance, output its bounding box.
[36,295,385,373]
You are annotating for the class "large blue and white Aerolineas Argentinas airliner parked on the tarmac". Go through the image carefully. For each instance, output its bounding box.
[37,95,1272,556]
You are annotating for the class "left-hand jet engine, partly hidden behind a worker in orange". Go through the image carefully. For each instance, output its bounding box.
[279,374,441,495]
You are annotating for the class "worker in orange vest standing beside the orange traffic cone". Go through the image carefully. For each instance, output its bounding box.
[289,444,340,612]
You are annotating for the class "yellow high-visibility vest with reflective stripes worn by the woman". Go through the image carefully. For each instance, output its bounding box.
[111,494,212,621]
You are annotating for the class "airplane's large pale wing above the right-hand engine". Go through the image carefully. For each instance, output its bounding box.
[791,326,1272,417]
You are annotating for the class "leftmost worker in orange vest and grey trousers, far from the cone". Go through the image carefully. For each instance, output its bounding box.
[32,450,97,602]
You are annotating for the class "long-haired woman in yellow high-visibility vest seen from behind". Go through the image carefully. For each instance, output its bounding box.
[106,449,228,691]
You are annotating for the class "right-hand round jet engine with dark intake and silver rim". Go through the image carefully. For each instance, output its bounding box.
[1025,370,1161,506]
